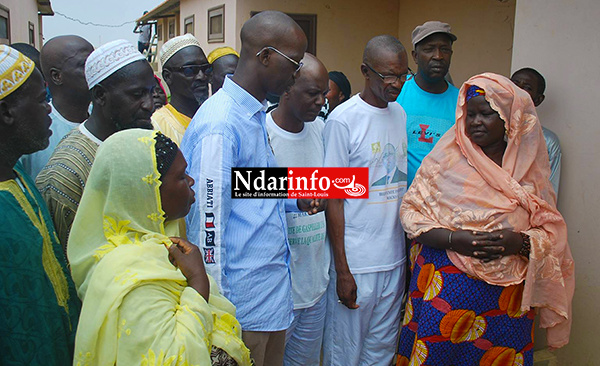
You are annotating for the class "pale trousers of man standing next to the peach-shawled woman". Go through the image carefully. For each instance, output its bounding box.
[323,264,406,366]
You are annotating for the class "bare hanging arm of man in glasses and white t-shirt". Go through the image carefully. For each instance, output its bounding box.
[325,199,358,309]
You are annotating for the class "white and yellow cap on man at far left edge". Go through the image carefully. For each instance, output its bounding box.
[0,45,35,100]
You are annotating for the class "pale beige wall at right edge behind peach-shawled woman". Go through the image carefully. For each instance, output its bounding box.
[512,0,600,366]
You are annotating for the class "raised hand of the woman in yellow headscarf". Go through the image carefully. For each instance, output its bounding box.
[168,237,210,301]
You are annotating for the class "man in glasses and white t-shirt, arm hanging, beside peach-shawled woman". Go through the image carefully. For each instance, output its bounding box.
[323,35,408,366]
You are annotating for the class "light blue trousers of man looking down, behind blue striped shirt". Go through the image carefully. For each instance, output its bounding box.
[283,293,327,366]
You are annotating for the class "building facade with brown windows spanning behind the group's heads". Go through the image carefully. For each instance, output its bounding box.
[139,0,516,91]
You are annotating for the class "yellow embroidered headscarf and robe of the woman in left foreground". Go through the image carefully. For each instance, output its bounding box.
[68,129,250,365]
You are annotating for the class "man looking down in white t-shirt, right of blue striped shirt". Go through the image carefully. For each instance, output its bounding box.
[267,53,331,366]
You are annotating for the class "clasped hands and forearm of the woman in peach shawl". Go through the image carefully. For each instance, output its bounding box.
[416,228,523,262]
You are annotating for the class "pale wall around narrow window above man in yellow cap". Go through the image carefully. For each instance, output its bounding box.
[179,0,239,55]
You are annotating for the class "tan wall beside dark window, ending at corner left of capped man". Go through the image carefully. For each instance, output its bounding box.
[236,0,398,94]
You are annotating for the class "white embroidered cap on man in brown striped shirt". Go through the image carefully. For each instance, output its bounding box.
[85,39,146,89]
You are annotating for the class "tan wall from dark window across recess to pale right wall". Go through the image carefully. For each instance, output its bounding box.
[236,0,515,93]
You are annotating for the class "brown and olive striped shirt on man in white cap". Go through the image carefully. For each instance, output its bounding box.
[35,124,100,255]
